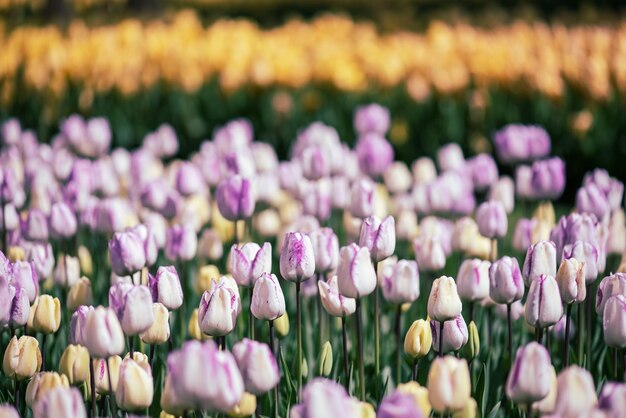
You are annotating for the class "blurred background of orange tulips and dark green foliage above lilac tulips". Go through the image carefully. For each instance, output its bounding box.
[0,0,626,200]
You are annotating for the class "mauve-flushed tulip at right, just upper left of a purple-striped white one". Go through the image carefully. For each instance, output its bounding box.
[489,256,524,304]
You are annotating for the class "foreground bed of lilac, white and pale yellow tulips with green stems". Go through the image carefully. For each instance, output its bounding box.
[0,104,626,418]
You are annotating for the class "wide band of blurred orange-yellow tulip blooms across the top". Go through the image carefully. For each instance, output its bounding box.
[0,10,626,103]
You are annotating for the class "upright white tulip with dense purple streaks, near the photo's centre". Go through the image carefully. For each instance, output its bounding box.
[280,232,315,282]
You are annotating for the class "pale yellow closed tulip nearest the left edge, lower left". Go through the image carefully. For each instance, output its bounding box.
[2,335,41,380]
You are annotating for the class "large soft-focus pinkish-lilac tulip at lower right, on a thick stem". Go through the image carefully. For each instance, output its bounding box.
[506,341,552,405]
